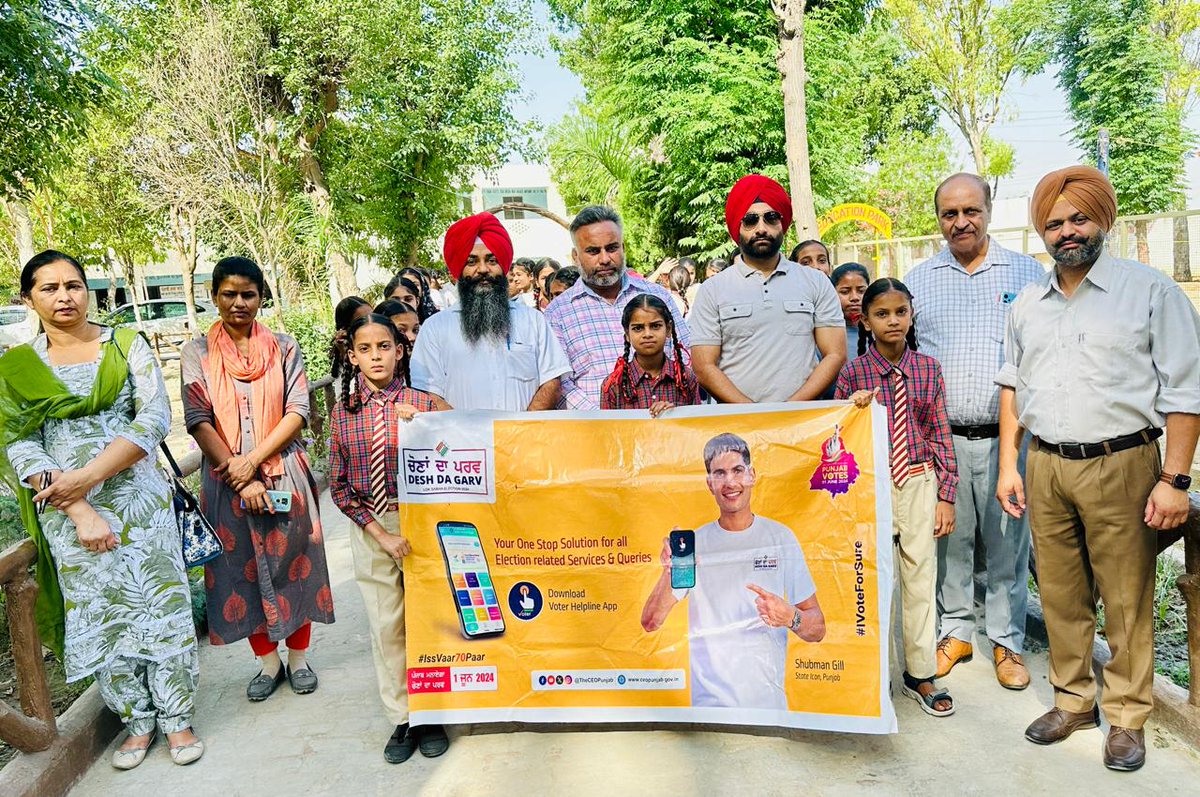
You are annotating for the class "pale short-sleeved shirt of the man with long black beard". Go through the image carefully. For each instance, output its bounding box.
[412,299,571,412]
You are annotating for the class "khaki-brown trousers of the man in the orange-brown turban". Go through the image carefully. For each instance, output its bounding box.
[1026,443,1162,729]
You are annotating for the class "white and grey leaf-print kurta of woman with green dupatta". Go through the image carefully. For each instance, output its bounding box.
[8,329,196,681]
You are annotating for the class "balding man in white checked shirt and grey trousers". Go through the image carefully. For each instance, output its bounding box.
[905,174,1045,689]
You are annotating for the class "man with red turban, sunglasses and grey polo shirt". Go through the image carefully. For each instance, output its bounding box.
[688,174,846,403]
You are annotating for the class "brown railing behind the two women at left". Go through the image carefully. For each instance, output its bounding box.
[0,377,335,753]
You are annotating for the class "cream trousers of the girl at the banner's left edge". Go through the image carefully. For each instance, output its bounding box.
[350,511,408,725]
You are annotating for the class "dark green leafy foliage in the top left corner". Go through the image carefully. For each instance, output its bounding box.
[0,0,110,194]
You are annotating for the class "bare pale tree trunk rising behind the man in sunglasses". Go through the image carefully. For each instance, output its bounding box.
[770,0,817,240]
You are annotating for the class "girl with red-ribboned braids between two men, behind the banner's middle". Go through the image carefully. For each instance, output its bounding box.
[600,293,700,418]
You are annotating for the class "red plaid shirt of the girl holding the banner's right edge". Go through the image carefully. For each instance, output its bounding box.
[834,346,959,503]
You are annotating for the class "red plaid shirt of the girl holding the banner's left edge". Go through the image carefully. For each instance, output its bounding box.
[329,374,437,526]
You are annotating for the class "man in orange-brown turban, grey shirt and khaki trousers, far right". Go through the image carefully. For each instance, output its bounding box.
[996,166,1200,771]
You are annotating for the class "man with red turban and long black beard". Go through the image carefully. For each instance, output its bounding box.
[412,212,571,412]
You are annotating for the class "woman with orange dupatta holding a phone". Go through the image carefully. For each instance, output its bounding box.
[180,257,334,702]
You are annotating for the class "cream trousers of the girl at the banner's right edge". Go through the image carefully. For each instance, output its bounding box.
[892,468,937,678]
